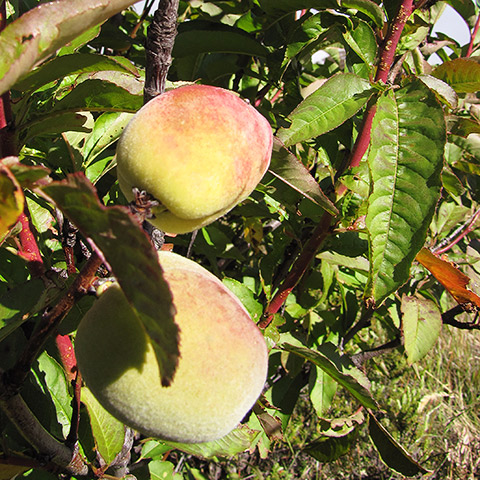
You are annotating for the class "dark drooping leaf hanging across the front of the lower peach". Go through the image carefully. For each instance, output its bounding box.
[42,174,179,386]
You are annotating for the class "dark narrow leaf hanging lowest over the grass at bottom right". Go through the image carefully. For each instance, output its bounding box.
[368,413,431,477]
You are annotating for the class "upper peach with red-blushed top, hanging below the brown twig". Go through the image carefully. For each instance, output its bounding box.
[117,85,273,233]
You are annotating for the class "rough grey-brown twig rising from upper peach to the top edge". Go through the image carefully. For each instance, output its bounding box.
[143,0,179,103]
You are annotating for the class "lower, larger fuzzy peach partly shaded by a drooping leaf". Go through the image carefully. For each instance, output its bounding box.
[75,252,268,443]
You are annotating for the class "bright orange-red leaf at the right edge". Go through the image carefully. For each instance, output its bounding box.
[416,248,480,311]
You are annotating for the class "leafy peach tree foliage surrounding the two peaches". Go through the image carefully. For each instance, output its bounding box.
[0,0,480,479]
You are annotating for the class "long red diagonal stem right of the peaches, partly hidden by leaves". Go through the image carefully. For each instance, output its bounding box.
[258,0,415,328]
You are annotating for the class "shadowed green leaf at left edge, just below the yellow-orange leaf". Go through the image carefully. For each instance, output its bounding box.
[0,279,45,342]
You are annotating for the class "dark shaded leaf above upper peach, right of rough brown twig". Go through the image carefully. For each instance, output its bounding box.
[172,20,268,58]
